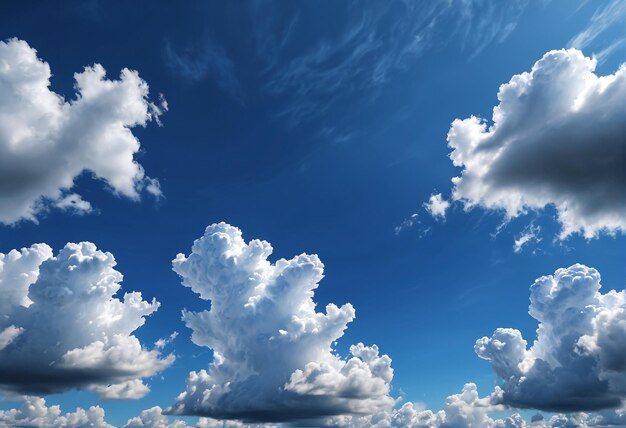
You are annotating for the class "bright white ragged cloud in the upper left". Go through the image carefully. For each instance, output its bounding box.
[0,39,167,224]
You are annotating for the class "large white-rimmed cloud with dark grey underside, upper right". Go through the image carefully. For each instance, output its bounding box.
[448,49,626,238]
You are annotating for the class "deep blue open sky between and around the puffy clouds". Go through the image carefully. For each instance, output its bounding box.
[0,0,626,423]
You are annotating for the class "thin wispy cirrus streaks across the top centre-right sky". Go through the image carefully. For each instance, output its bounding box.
[253,0,528,126]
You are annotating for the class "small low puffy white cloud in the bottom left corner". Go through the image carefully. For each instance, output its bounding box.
[0,397,113,428]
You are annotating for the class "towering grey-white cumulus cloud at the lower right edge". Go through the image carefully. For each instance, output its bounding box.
[475,264,626,411]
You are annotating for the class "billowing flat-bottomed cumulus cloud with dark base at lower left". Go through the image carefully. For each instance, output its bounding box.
[0,242,174,399]
